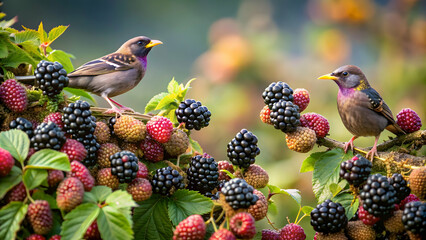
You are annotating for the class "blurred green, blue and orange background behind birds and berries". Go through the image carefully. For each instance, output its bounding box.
[1,0,426,239]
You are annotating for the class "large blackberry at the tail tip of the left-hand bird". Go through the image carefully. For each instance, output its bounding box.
[34,60,69,97]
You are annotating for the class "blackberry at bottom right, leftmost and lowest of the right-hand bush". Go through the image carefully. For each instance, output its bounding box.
[311,199,348,234]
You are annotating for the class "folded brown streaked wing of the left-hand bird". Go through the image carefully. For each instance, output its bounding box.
[68,53,136,77]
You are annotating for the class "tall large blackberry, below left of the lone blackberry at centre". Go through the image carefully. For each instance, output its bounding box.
[186,155,219,193]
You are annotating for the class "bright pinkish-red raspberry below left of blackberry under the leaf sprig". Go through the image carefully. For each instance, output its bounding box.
[146,116,173,143]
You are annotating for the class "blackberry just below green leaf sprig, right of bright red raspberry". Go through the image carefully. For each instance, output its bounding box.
[175,99,211,130]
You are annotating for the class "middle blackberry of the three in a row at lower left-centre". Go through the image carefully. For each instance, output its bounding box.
[151,167,185,196]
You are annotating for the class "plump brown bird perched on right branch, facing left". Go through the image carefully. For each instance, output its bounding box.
[318,65,406,161]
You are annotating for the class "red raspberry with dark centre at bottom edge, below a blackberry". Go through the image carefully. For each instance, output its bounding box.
[229,212,256,239]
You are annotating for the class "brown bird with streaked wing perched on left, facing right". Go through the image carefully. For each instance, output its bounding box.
[68,36,162,114]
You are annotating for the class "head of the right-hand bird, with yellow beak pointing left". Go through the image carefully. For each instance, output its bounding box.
[318,65,370,90]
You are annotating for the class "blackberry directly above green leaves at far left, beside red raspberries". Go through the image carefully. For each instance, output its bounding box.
[31,122,66,151]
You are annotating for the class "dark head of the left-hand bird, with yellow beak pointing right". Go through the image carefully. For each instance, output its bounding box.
[117,36,163,57]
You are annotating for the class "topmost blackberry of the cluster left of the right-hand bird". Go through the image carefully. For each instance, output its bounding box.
[262,81,293,110]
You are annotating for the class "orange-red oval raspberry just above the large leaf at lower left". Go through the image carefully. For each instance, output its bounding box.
[56,177,84,212]
